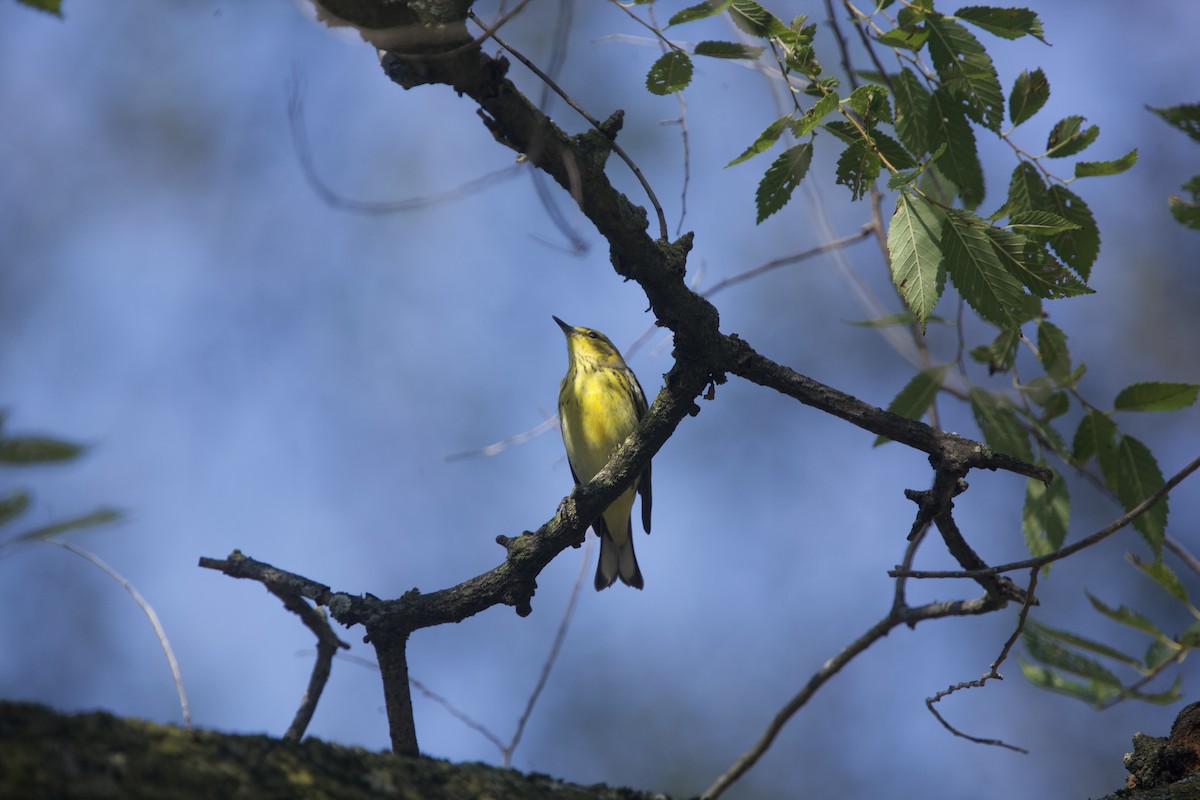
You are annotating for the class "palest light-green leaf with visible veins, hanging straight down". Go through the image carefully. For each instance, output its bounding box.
[888,192,946,330]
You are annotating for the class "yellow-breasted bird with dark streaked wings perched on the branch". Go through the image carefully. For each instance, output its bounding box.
[553,317,652,591]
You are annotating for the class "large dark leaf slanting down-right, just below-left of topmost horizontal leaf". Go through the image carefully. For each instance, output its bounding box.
[925,17,1004,133]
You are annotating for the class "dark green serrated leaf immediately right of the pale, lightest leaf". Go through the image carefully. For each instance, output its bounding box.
[942,209,1024,327]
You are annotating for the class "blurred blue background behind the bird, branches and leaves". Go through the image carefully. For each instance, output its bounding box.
[0,0,1200,799]
